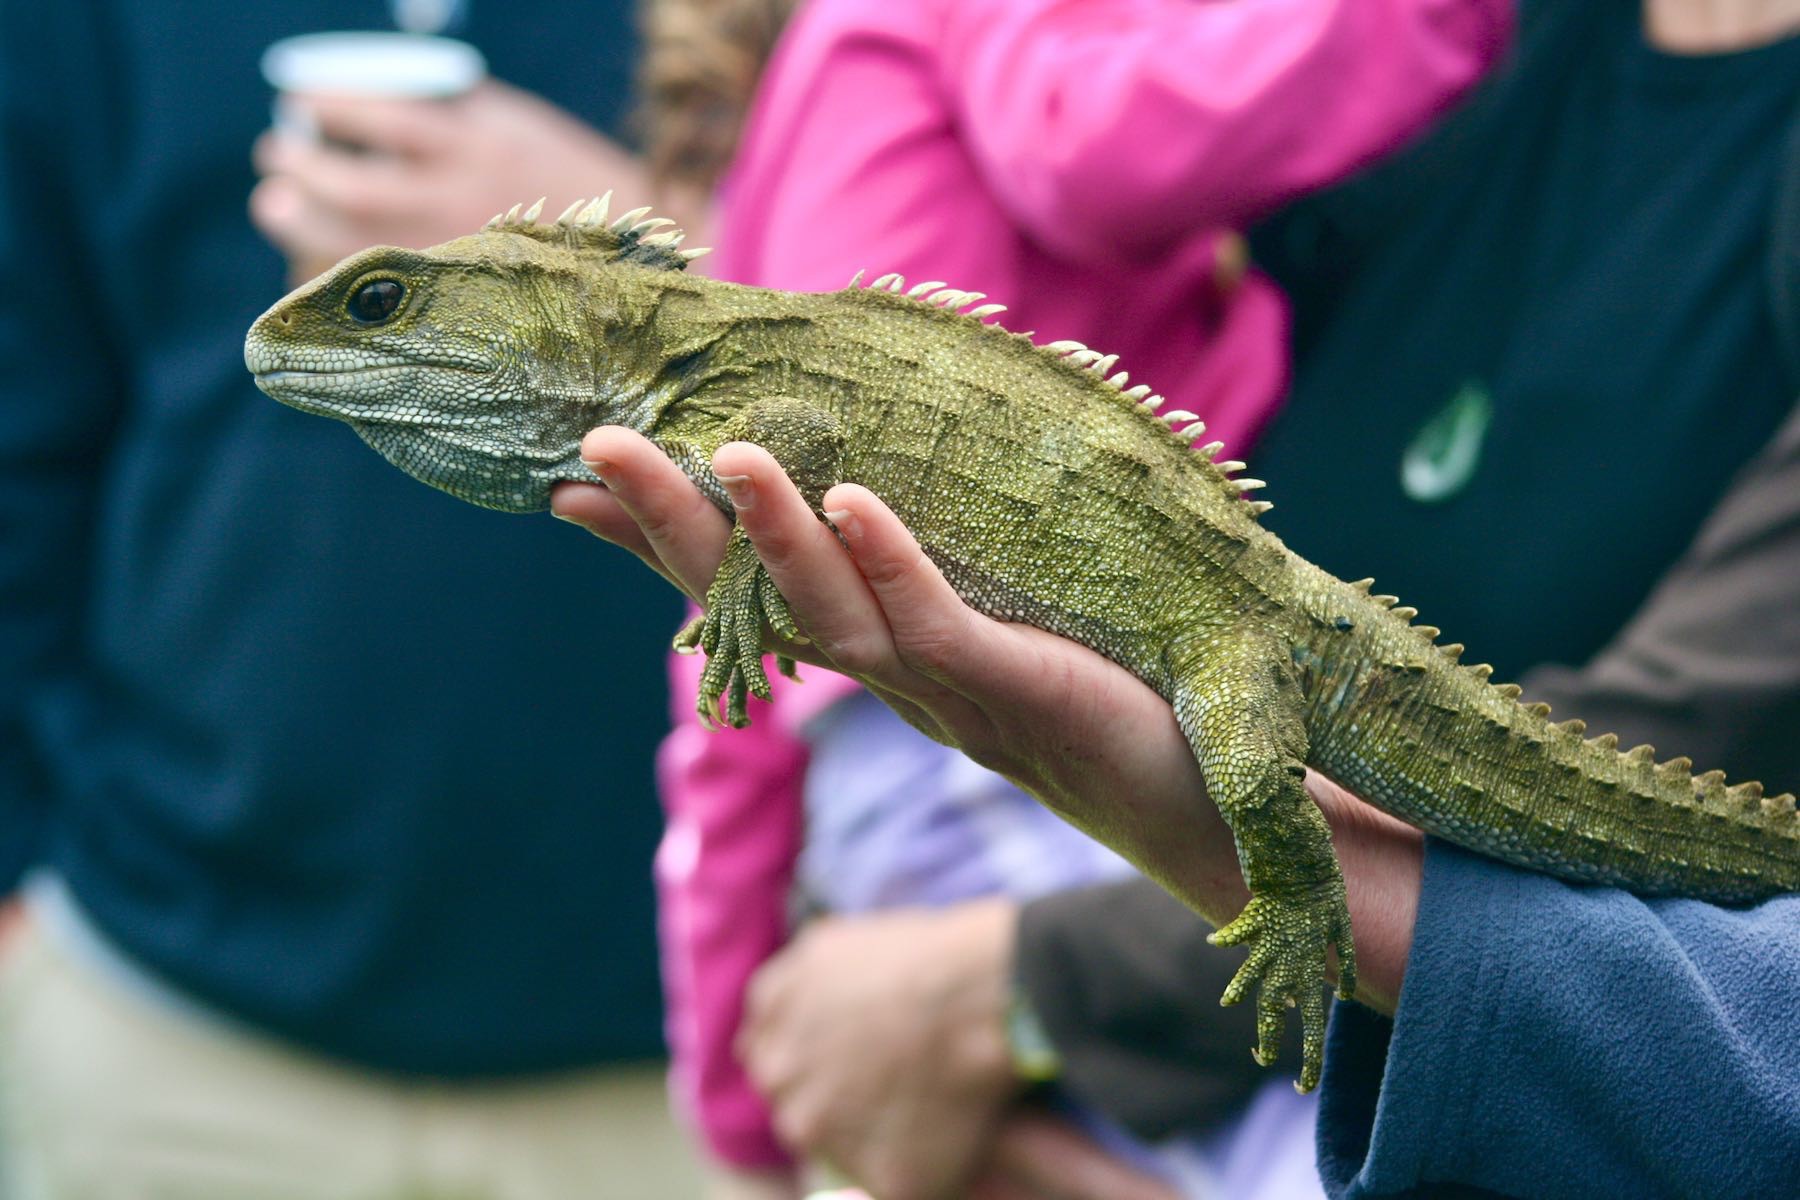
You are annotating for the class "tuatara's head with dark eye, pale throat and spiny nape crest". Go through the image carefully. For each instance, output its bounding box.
[243,198,695,513]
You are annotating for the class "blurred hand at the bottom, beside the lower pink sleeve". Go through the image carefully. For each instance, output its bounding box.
[738,900,1022,1200]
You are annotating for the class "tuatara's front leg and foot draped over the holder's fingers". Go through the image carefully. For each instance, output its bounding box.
[675,396,844,729]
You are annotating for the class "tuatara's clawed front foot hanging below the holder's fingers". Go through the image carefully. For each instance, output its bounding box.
[675,527,799,729]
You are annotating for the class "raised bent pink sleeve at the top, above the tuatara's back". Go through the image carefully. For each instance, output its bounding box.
[941,0,1512,259]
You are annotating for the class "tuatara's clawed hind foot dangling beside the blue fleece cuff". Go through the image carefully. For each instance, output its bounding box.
[1208,880,1355,1092]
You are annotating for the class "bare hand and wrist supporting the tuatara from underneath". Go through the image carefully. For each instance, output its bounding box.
[553,426,1422,1013]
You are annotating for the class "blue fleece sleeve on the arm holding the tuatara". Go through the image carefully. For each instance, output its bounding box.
[1319,840,1800,1200]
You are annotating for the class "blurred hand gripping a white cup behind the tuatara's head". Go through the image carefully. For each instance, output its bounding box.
[250,79,669,282]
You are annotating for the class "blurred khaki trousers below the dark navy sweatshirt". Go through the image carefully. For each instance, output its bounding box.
[0,919,700,1200]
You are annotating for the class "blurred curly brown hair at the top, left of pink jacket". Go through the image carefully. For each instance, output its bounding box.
[637,0,801,193]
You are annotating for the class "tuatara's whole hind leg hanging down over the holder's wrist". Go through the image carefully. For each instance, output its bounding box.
[1175,630,1355,1092]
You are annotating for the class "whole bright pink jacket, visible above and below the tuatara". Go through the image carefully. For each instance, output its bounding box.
[657,0,1512,1166]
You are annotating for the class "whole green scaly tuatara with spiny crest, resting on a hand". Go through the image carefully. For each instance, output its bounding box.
[245,201,1800,1090]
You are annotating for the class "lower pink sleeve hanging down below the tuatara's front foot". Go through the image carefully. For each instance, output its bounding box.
[655,636,855,1168]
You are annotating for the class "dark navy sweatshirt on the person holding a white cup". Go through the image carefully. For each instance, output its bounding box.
[0,2,679,1078]
